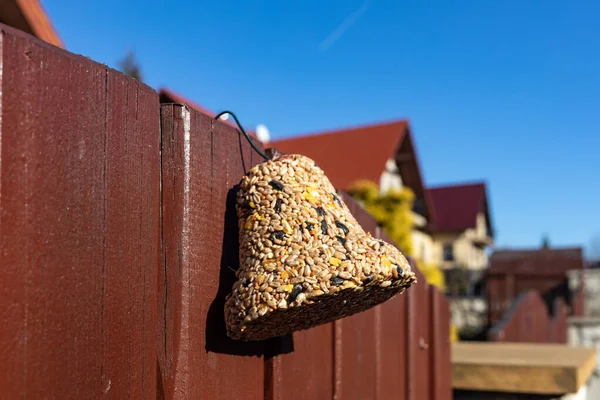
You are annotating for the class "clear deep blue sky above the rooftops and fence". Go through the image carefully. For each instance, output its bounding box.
[43,0,600,256]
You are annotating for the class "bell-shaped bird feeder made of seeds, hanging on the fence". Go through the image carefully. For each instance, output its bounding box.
[225,155,416,340]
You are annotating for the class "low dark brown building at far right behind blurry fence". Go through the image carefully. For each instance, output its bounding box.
[487,246,585,324]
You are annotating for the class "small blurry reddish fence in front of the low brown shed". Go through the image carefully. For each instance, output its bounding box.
[488,290,567,343]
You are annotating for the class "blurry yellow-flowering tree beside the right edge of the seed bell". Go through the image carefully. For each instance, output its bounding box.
[347,180,458,342]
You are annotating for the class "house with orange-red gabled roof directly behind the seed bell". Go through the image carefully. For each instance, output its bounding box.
[269,120,433,263]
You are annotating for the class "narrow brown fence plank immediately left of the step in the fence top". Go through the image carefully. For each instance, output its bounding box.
[102,72,160,398]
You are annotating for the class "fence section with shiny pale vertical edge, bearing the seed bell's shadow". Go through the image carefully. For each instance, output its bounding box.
[159,104,264,399]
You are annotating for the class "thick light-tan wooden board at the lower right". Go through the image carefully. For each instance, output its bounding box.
[452,343,596,394]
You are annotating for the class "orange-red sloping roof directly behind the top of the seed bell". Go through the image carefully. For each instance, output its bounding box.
[269,121,408,189]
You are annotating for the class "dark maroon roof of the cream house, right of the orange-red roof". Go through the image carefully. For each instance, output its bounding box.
[428,182,492,234]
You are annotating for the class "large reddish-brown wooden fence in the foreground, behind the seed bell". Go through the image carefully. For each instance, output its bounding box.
[0,26,452,400]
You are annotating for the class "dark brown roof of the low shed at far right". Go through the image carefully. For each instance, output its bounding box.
[489,247,585,275]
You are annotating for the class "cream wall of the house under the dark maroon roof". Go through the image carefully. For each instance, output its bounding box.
[433,213,488,270]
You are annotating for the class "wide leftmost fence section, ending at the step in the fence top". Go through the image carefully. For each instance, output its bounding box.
[0,27,160,398]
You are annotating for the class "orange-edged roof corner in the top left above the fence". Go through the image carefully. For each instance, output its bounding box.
[0,0,64,48]
